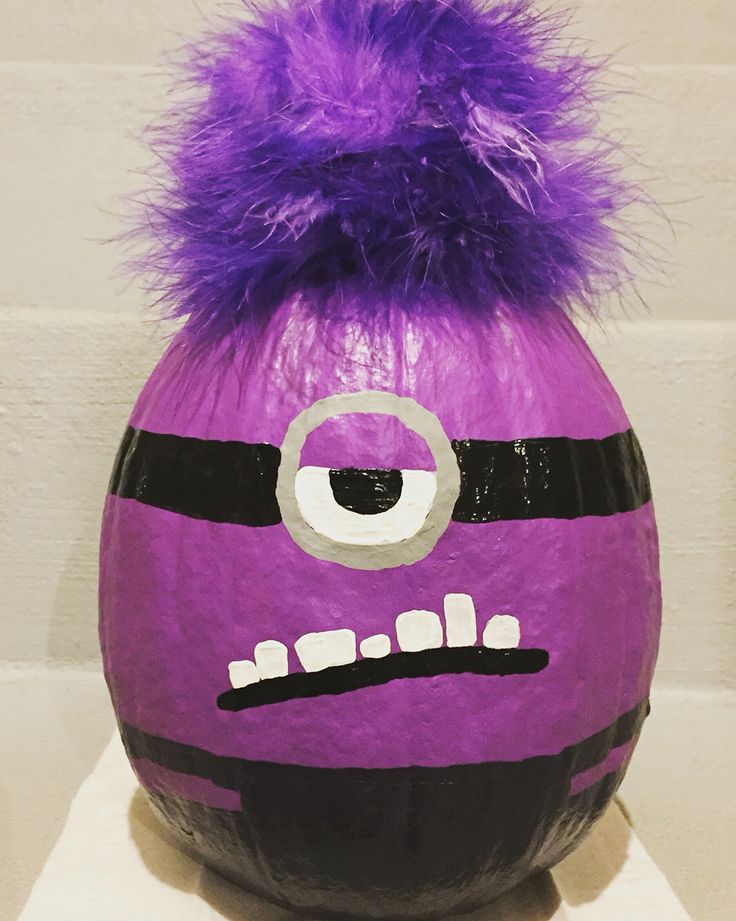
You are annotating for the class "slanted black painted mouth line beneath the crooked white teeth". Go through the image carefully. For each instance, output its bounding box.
[217,646,549,712]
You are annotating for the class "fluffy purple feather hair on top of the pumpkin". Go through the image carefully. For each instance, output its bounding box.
[137,0,635,340]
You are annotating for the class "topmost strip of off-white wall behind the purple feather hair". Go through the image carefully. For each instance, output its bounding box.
[0,0,736,66]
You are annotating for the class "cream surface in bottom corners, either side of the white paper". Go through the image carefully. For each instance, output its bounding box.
[5,668,736,921]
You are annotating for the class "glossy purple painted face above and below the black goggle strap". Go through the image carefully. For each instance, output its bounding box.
[101,304,660,768]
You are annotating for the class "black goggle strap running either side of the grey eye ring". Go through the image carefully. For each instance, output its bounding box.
[109,428,651,527]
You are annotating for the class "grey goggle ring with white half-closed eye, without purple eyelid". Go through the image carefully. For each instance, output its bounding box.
[276,390,460,569]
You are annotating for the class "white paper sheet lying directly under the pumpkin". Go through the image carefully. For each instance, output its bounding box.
[19,733,690,921]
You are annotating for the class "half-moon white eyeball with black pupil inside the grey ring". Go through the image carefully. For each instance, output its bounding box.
[296,467,437,546]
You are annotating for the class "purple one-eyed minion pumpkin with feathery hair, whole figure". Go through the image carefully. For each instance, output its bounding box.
[100,0,660,918]
